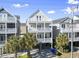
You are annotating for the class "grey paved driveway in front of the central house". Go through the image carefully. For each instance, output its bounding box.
[31,49,55,58]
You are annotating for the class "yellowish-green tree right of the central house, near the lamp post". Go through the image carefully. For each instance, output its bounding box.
[55,33,69,53]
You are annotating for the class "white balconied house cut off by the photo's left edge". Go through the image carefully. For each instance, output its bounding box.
[0,8,20,46]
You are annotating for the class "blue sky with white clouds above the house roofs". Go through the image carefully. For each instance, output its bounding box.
[0,0,79,22]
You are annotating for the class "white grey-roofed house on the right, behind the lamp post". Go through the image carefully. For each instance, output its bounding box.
[52,16,79,46]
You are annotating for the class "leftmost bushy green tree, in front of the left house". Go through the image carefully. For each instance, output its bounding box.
[5,36,19,57]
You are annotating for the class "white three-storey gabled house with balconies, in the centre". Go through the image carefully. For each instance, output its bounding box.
[27,10,52,47]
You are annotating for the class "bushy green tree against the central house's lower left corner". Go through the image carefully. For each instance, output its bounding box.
[20,33,37,55]
